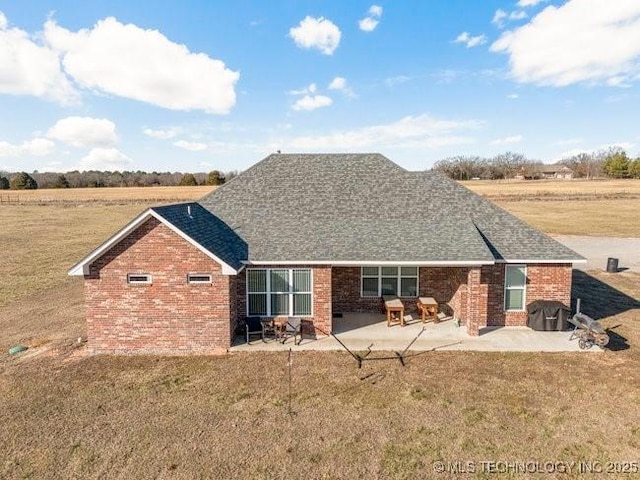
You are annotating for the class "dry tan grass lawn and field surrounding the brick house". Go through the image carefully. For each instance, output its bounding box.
[0,182,640,479]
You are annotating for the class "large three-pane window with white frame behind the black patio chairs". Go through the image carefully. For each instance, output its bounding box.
[247,268,312,317]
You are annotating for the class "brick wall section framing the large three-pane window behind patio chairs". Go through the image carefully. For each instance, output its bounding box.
[235,265,332,335]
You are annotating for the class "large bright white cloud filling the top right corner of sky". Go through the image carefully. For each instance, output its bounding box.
[491,0,640,86]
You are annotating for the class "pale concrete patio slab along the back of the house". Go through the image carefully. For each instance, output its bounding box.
[231,313,602,352]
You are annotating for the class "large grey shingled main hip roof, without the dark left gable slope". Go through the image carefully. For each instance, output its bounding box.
[198,154,582,265]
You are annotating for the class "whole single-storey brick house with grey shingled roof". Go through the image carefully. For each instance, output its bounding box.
[69,154,583,354]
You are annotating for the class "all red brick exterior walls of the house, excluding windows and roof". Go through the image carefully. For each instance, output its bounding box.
[85,218,572,354]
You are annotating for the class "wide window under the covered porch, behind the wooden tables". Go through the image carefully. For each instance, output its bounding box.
[361,267,418,297]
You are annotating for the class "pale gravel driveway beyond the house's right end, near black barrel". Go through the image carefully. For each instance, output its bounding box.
[553,235,640,272]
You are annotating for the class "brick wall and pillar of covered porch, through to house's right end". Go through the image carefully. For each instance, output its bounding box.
[332,264,572,335]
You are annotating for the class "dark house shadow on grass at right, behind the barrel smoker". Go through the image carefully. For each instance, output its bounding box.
[571,270,640,351]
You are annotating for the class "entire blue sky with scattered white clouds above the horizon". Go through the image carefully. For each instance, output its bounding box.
[0,0,640,172]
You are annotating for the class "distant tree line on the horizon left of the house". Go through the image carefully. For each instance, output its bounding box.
[0,170,238,190]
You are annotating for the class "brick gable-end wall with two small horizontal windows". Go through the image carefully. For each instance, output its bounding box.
[85,218,236,354]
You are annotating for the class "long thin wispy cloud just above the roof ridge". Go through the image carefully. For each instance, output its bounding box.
[289,114,483,151]
